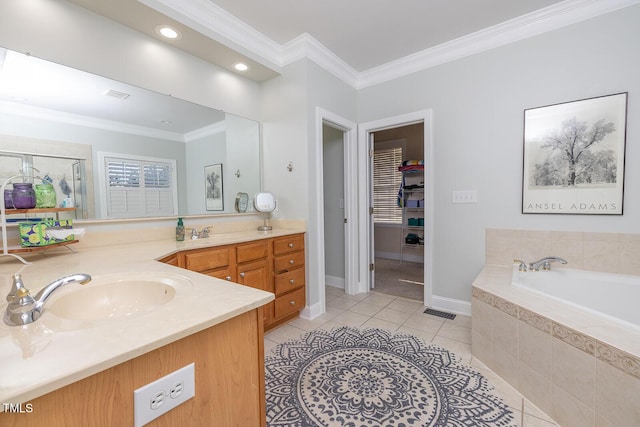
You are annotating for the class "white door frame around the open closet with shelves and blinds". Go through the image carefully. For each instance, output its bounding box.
[358,109,434,307]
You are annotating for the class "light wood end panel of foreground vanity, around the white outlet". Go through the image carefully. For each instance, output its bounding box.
[0,307,266,427]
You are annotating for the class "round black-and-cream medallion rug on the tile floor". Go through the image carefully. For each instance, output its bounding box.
[265,326,516,427]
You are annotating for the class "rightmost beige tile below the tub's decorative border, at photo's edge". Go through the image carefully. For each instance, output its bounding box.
[595,360,640,426]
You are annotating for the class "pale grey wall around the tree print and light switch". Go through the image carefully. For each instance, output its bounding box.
[358,6,640,301]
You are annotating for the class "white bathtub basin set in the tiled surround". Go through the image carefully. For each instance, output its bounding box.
[511,267,640,328]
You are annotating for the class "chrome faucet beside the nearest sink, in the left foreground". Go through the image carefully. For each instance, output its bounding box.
[4,273,91,326]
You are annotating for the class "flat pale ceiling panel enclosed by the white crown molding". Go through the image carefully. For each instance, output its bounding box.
[204,0,560,72]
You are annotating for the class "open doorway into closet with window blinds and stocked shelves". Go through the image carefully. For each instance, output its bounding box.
[371,122,424,301]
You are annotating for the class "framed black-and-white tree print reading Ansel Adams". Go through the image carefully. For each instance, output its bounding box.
[522,92,627,215]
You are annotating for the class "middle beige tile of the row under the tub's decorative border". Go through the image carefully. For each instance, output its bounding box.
[518,321,553,380]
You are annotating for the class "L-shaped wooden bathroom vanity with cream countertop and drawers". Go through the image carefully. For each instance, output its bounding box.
[0,229,305,427]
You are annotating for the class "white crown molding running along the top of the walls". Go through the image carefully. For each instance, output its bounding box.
[138,0,640,89]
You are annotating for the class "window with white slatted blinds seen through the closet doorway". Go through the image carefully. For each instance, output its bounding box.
[373,147,402,224]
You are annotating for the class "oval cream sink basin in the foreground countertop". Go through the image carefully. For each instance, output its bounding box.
[45,274,191,320]
